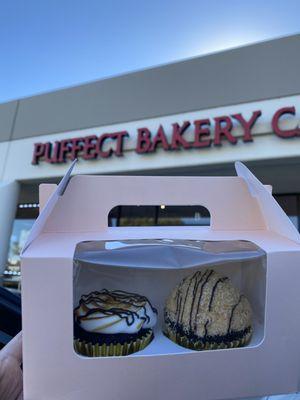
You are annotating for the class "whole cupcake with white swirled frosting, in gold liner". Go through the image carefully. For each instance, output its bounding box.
[74,289,157,357]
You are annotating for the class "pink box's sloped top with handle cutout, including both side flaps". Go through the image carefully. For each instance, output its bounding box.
[25,162,300,242]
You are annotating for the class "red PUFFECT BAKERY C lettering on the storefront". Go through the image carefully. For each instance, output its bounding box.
[32,107,300,165]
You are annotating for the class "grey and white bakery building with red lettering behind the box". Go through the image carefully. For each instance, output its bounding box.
[0,35,300,284]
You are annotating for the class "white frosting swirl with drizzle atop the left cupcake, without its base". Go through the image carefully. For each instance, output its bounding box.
[74,289,157,334]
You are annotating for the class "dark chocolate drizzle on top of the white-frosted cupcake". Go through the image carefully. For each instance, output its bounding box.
[74,289,157,326]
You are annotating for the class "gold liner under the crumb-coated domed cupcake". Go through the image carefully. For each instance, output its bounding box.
[164,327,252,351]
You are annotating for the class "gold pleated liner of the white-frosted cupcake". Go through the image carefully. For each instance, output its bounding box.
[74,331,153,357]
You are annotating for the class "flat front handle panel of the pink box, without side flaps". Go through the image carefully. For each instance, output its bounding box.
[43,166,266,232]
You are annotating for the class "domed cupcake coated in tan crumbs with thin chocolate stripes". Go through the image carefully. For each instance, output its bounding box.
[164,269,252,350]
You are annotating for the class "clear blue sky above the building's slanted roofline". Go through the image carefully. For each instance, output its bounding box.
[0,0,300,103]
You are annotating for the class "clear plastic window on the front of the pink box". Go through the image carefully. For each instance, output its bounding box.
[73,239,266,357]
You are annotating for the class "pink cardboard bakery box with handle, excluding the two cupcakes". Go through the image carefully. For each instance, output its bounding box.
[21,162,300,400]
